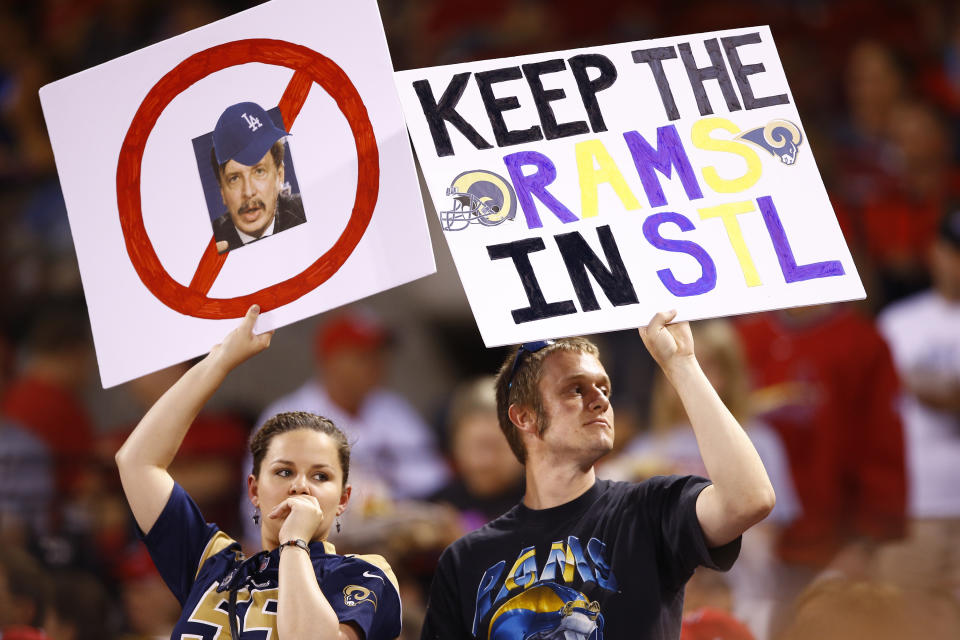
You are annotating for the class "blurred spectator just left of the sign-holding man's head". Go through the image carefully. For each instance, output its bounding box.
[430,376,523,535]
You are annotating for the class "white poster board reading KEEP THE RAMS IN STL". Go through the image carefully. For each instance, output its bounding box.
[395,27,865,346]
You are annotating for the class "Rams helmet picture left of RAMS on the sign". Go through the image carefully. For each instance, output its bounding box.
[440,169,517,231]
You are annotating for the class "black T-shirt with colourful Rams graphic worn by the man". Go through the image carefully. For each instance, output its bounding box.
[421,476,740,640]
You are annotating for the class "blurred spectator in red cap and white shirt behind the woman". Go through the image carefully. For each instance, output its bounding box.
[244,308,449,539]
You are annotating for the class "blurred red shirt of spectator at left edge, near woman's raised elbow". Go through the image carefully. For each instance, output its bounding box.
[0,377,93,494]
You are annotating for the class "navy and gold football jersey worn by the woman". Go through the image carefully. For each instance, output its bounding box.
[143,484,400,640]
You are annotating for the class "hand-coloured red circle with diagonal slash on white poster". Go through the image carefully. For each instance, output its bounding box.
[117,39,380,319]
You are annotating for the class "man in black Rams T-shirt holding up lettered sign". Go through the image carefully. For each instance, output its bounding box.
[422,312,774,640]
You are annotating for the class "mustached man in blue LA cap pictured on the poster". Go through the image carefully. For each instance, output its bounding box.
[210,102,306,253]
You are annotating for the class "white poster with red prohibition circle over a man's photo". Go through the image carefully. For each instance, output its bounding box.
[40,0,435,387]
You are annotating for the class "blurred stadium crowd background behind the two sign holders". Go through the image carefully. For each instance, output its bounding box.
[0,0,960,640]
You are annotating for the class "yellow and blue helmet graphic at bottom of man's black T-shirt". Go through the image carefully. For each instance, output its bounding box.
[489,582,603,640]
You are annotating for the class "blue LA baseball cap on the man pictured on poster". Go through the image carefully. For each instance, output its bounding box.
[213,102,290,166]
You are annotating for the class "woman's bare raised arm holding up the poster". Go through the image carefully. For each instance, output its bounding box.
[116,305,273,533]
